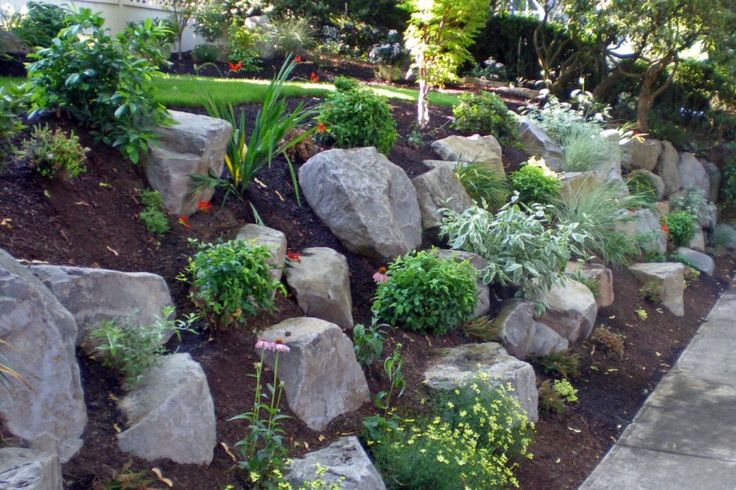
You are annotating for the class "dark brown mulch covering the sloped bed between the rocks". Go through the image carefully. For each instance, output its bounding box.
[0,96,733,490]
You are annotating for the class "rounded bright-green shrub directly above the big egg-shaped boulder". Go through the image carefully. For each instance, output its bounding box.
[317,83,398,154]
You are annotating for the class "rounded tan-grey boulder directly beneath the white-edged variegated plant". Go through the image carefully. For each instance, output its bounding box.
[537,278,598,343]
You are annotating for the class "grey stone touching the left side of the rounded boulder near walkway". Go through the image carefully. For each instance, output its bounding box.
[493,300,569,360]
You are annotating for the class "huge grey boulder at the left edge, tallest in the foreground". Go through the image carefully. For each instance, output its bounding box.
[0,250,87,463]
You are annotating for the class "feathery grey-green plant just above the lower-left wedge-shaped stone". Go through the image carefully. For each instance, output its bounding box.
[90,306,197,386]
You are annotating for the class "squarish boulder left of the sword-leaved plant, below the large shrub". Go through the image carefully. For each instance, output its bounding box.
[142,111,233,216]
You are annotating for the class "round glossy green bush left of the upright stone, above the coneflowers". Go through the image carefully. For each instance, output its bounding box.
[186,240,286,327]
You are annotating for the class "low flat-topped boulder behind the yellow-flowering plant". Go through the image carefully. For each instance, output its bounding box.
[424,342,539,422]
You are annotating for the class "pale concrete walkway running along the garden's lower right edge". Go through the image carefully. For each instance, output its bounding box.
[580,282,736,490]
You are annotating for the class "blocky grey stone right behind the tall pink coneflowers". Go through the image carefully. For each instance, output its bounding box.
[259,317,370,431]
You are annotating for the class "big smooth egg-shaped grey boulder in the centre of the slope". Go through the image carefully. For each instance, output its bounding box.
[299,147,422,260]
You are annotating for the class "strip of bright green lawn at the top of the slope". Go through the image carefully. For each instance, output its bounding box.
[0,75,457,107]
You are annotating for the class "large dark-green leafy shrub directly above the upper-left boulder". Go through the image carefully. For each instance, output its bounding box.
[28,9,169,163]
